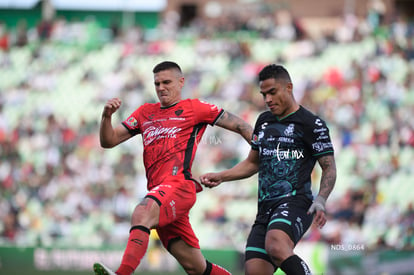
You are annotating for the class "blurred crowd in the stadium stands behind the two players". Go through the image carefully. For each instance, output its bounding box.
[0,3,414,256]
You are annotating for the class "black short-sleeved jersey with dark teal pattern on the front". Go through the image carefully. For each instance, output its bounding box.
[252,106,334,204]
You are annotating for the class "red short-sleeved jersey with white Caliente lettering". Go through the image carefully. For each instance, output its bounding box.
[122,99,224,190]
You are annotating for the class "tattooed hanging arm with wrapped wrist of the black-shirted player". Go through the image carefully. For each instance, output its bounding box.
[308,155,336,227]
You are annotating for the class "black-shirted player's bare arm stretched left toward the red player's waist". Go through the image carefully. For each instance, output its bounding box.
[200,149,259,190]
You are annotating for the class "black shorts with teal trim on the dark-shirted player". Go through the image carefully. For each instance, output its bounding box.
[245,195,313,263]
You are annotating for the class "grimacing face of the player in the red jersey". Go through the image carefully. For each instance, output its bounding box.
[154,70,184,107]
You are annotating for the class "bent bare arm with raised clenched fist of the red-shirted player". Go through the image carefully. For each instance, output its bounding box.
[99,98,132,148]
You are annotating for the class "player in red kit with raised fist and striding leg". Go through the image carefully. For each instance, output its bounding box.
[94,61,253,275]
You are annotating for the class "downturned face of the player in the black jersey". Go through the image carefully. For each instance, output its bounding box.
[259,78,297,118]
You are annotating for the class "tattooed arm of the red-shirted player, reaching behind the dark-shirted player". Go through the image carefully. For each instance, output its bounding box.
[215,111,253,144]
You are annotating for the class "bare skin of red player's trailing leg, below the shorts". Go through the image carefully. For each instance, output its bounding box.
[169,239,207,274]
